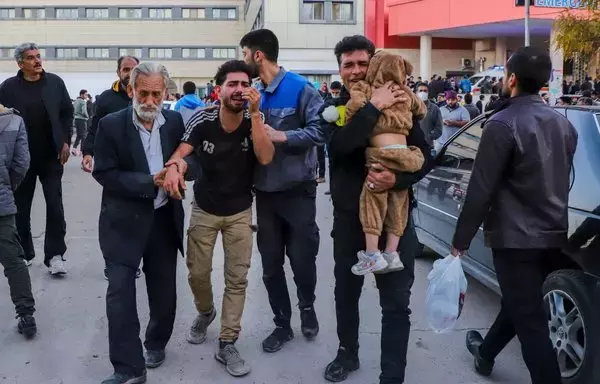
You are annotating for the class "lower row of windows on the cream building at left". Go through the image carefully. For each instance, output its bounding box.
[0,48,237,60]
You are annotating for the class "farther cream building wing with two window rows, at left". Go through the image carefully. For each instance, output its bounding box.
[0,0,246,97]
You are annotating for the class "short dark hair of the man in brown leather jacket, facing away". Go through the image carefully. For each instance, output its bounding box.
[506,46,552,94]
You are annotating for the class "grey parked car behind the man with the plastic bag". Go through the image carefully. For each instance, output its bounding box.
[414,106,600,384]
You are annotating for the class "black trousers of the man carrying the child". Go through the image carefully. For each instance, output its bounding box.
[331,211,418,384]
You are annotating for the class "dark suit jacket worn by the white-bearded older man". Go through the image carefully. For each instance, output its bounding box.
[92,107,185,268]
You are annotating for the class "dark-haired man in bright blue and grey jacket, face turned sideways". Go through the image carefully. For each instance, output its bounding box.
[240,29,325,352]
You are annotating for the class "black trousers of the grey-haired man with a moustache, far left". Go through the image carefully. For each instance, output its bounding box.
[15,158,67,265]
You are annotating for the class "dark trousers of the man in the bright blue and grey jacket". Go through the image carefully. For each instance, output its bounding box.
[256,181,320,327]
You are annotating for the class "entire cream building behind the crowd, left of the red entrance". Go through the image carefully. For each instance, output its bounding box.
[0,0,364,97]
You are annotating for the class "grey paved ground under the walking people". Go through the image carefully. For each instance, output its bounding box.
[0,159,528,384]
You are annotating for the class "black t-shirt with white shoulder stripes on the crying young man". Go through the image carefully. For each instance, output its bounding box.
[182,107,257,216]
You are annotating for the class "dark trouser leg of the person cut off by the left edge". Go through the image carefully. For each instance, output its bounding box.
[0,215,35,316]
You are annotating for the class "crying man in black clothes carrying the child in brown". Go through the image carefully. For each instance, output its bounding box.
[321,35,431,384]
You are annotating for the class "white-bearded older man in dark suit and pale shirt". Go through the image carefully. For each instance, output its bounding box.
[92,62,185,384]
